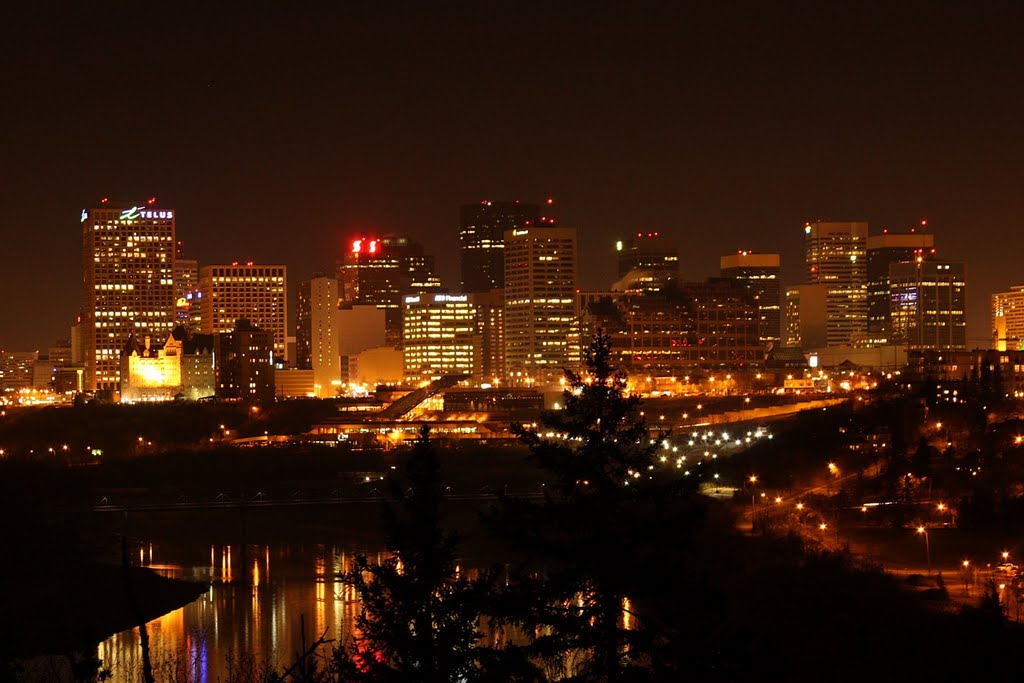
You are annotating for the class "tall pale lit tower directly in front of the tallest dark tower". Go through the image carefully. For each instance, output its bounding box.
[505,227,580,386]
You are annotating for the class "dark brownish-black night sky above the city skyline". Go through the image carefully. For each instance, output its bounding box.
[0,1,1024,350]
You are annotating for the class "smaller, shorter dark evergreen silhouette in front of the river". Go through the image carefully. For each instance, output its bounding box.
[335,427,486,683]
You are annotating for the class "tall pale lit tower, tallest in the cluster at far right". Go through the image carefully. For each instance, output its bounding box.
[803,222,867,348]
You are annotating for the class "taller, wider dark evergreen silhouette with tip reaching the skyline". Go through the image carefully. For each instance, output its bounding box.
[495,331,696,681]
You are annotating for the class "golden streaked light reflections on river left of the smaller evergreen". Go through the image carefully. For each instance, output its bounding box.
[98,544,368,683]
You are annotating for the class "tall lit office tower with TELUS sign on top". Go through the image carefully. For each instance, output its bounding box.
[81,199,175,391]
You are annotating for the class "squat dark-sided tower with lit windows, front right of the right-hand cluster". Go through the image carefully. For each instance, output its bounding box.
[889,257,967,351]
